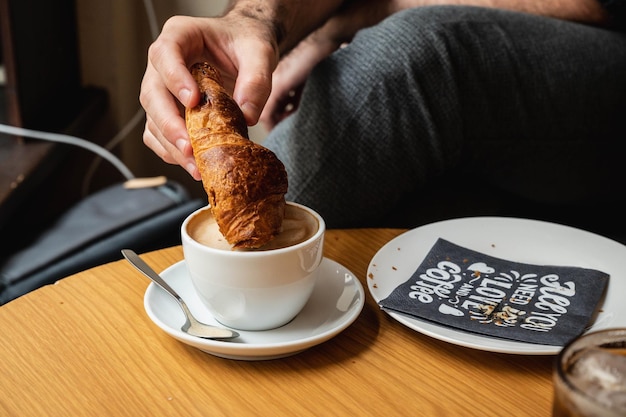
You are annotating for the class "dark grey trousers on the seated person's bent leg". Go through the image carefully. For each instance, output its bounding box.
[264,6,626,227]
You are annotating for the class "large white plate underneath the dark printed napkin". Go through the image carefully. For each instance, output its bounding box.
[367,217,626,355]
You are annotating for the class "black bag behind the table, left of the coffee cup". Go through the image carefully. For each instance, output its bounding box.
[0,181,207,305]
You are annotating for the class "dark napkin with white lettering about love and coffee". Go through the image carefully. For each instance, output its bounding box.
[379,239,609,346]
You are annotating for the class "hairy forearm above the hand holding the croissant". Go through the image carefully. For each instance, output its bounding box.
[227,0,343,52]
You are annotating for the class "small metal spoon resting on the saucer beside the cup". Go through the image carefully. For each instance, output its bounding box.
[122,249,239,340]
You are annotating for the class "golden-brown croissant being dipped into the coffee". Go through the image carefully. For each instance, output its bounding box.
[185,63,288,249]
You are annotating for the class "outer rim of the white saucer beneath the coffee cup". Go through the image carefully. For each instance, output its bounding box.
[144,257,365,360]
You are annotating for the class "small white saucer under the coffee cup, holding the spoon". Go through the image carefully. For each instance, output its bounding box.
[144,258,365,360]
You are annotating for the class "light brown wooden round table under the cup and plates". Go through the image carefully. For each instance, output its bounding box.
[0,229,553,417]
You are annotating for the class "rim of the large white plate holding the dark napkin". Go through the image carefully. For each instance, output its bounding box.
[366,216,626,355]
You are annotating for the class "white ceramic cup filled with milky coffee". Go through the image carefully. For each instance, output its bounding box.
[181,202,326,330]
